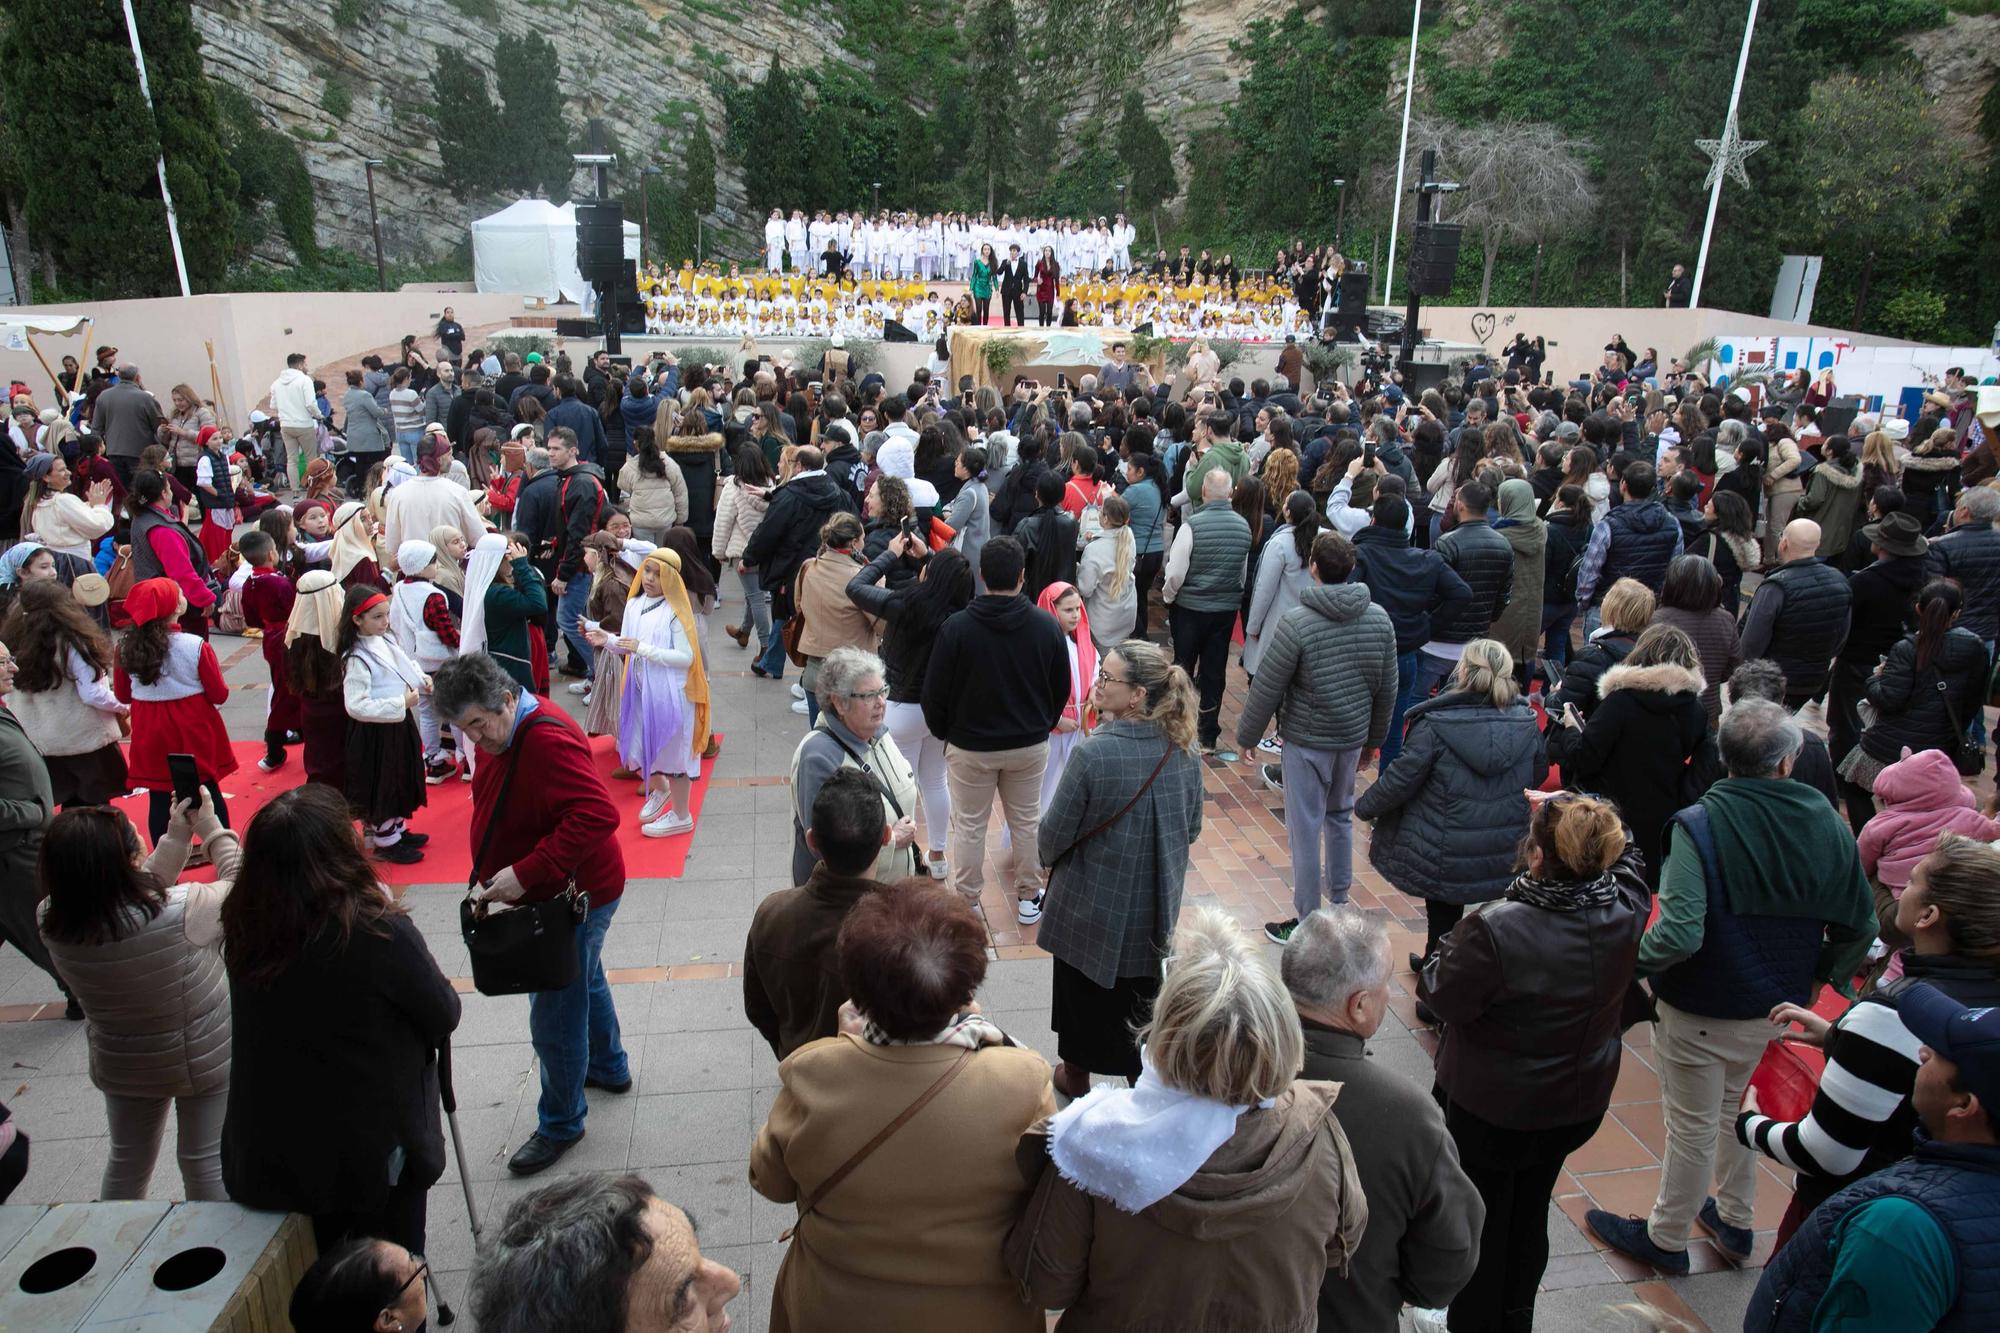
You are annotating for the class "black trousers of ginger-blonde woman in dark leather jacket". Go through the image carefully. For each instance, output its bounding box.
[1438,1093,1604,1333]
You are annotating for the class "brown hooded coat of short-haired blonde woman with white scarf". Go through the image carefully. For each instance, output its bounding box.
[1006,1083,1368,1333]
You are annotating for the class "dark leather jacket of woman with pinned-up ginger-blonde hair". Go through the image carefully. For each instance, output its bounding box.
[1416,851,1652,1129]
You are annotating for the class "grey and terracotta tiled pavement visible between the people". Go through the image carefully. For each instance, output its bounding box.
[0,602,1790,1329]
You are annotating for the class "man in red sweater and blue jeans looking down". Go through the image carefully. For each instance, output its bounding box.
[432,652,632,1175]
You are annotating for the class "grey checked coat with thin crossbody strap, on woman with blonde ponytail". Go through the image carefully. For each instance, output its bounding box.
[1036,721,1202,987]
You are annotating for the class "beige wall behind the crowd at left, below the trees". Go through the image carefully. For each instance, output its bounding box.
[0,292,522,426]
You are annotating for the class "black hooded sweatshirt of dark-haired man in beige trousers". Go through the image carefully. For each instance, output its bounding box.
[924,588,1070,751]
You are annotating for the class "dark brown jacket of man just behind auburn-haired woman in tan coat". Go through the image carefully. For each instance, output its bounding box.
[744,861,888,1056]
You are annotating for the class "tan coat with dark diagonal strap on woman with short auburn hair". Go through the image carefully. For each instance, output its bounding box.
[750,1037,1056,1333]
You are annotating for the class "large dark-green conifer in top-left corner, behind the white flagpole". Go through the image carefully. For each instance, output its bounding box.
[0,0,238,296]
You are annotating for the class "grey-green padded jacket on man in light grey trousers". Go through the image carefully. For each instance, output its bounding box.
[1236,584,1396,751]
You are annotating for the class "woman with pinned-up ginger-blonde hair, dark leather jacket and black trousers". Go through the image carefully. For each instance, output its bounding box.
[1416,792,1648,1329]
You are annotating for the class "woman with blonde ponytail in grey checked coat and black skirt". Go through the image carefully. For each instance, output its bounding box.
[1036,638,1202,1097]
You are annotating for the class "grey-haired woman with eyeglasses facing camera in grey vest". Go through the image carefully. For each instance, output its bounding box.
[792,640,924,885]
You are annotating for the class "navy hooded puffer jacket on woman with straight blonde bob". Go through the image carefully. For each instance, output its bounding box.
[1354,691,1548,903]
